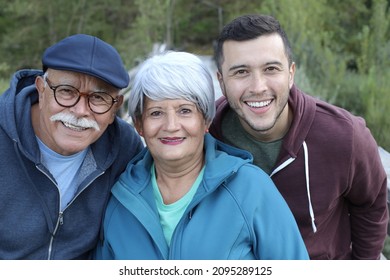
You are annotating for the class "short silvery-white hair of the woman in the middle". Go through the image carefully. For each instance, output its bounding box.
[128,51,215,123]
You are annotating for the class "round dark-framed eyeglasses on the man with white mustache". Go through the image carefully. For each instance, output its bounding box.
[45,78,118,114]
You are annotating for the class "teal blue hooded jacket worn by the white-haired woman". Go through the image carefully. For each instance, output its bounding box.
[96,134,308,260]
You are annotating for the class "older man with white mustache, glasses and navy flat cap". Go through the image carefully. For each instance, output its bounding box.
[0,34,143,259]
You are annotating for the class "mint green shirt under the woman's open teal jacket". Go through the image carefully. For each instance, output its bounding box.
[151,164,204,246]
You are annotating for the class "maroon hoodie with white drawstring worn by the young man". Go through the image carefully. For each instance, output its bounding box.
[210,85,389,259]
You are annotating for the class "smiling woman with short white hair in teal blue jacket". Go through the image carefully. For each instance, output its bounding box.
[96,52,308,260]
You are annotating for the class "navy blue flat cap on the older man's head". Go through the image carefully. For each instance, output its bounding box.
[42,34,130,89]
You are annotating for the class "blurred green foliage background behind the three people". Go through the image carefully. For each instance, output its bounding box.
[0,0,390,258]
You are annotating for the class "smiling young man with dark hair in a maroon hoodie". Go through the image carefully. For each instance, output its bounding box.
[210,15,388,259]
